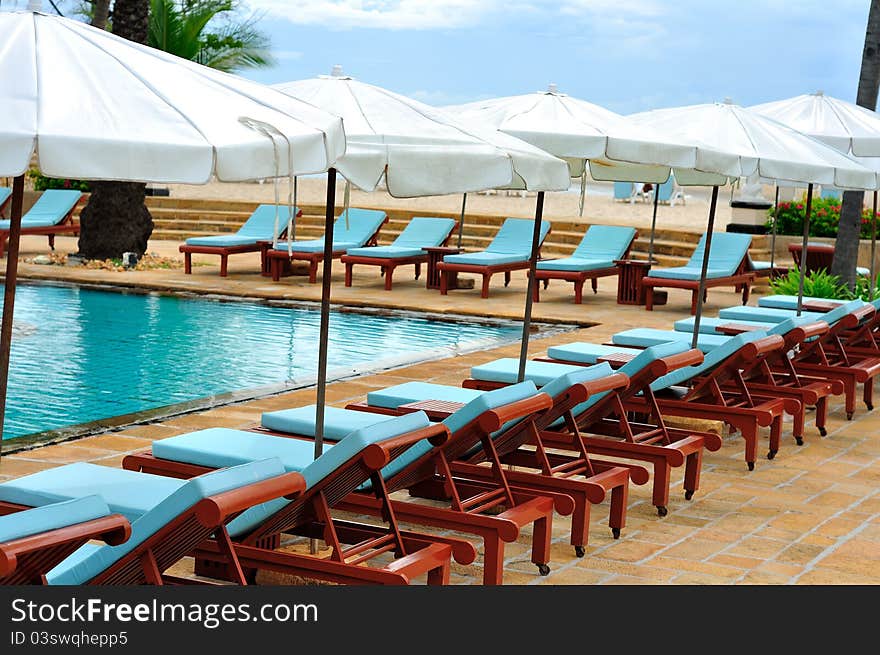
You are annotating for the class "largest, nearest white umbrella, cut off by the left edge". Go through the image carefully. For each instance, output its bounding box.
[0,6,345,456]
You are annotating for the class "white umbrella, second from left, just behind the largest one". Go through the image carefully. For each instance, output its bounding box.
[275,66,570,453]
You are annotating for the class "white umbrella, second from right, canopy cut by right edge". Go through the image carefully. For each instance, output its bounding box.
[630,100,877,346]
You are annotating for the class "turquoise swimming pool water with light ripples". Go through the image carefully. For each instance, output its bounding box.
[0,285,522,439]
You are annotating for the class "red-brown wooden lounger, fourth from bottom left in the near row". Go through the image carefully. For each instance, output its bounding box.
[160,382,556,584]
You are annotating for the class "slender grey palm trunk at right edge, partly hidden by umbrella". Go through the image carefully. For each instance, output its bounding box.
[831,0,880,289]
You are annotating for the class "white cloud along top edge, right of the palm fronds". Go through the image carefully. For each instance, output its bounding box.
[250,0,502,30]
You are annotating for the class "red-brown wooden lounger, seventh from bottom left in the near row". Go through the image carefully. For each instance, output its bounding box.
[547,332,798,471]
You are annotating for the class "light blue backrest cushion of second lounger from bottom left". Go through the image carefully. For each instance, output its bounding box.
[46,458,284,585]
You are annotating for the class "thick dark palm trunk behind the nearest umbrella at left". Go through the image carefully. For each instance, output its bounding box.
[79,0,153,259]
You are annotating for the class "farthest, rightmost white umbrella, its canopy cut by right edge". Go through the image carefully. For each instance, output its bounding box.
[749,91,880,284]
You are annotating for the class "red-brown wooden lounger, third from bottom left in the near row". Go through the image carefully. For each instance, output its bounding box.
[123,413,476,584]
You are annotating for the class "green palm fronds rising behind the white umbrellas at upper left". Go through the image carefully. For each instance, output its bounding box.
[147,0,274,72]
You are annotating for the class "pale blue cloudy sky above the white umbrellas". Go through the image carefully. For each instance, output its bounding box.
[8,0,869,114]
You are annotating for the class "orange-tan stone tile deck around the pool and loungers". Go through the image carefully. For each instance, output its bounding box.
[0,237,880,585]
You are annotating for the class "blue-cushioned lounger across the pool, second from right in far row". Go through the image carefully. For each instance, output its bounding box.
[533,225,638,304]
